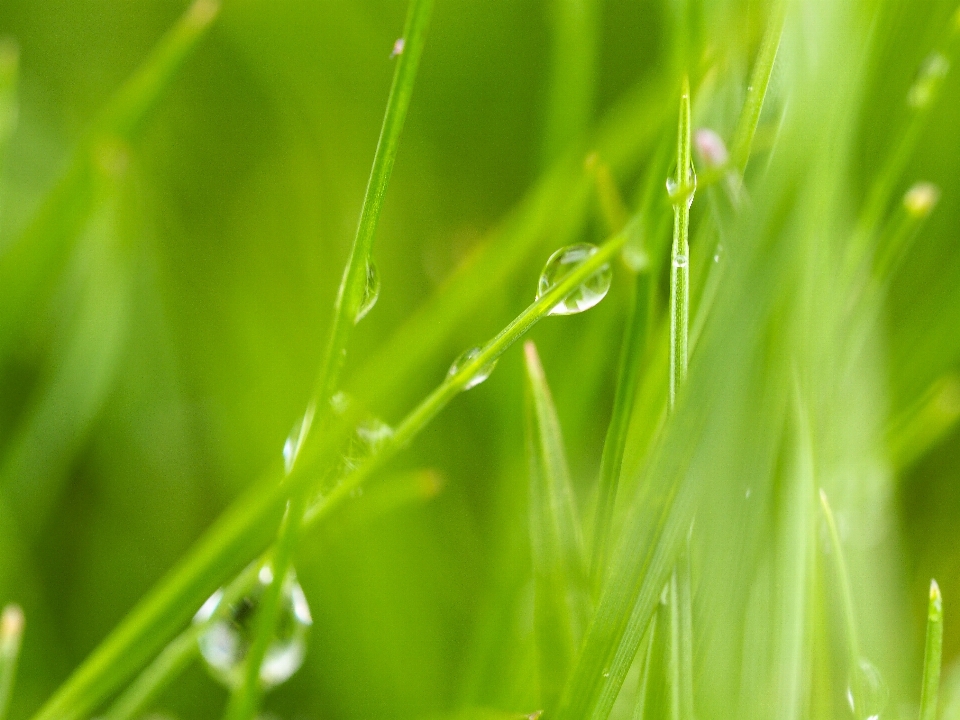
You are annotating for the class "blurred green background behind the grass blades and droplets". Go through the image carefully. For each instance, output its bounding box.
[0,0,960,718]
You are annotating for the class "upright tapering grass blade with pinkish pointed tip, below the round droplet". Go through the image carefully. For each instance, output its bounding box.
[523,341,587,707]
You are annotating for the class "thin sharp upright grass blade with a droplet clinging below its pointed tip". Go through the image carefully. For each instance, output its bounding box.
[668,77,697,408]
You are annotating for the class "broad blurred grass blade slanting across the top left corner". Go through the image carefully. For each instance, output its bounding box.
[0,0,219,357]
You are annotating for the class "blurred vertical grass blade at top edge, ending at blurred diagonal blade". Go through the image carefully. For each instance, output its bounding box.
[542,0,601,167]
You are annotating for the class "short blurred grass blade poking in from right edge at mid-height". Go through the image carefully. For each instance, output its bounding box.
[887,374,960,471]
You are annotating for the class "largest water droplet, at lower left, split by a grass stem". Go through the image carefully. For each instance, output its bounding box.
[193,566,313,689]
